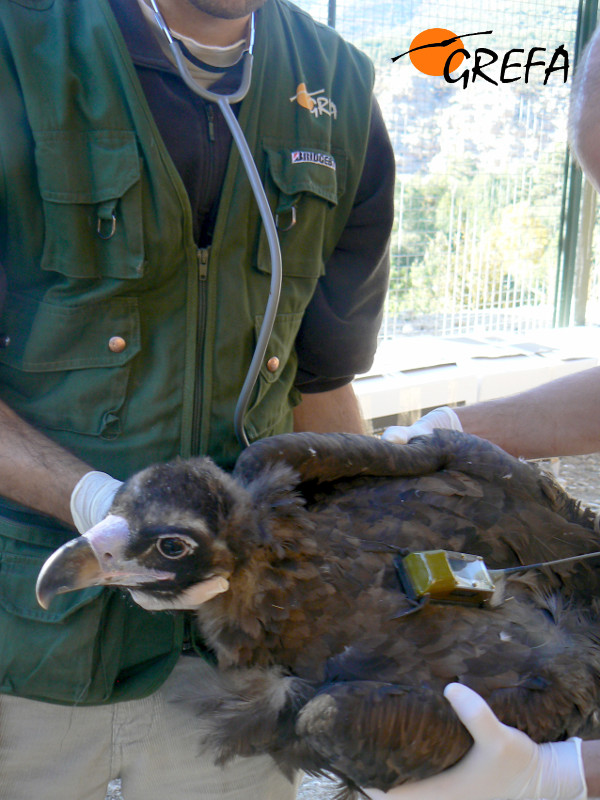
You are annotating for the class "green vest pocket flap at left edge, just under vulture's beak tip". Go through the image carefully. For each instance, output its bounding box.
[0,551,104,623]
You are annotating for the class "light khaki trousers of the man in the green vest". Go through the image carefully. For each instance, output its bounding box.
[0,656,301,800]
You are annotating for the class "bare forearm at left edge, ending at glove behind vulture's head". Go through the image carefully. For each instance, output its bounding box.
[0,401,91,525]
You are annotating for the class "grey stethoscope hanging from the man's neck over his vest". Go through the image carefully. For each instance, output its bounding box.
[150,0,282,447]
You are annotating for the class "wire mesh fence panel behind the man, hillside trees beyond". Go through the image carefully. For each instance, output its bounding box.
[292,0,588,338]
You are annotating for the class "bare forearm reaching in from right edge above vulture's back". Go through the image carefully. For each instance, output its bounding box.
[455,367,600,458]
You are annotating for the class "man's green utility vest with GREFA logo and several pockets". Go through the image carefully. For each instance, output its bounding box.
[0,0,372,704]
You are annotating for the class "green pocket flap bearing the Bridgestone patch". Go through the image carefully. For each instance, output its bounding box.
[264,144,346,206]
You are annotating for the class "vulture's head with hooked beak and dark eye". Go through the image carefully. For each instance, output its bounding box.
[38,458,270,610]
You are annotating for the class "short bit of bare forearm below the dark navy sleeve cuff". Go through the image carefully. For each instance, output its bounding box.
[294,383,367,433]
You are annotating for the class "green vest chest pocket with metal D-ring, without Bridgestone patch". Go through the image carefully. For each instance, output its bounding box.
[35,131,144,278]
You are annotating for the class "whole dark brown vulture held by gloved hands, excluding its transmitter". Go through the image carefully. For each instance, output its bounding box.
[38,431,600,795]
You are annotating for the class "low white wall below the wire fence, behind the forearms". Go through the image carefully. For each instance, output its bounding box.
[354,326,600,431]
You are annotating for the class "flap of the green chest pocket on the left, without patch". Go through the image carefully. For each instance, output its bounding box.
[35,131,140,204]
